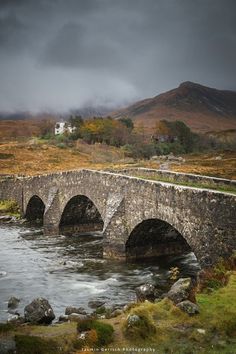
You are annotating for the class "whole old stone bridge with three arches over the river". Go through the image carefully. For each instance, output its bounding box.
[0,170,236,266]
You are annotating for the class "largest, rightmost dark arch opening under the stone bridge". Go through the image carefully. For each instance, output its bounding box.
[125,218,191,261]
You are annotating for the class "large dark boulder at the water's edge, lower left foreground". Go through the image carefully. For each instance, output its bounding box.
[24,297,55,324]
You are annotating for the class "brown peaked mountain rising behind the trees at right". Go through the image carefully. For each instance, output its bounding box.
[111,81,236,132]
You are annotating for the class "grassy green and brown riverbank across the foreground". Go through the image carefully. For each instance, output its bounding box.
[0,271,236,354]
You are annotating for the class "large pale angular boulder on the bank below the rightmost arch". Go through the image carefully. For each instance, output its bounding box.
[167,278,192,304]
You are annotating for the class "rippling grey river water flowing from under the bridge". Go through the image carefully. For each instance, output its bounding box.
[0,224,199,321]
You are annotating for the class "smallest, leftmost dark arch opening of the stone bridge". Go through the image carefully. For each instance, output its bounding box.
[25,194,45,224]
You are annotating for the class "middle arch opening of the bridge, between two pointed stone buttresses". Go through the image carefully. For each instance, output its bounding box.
[59,194,104,235]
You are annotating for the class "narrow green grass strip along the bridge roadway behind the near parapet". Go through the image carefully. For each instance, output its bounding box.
[136,175,236,194]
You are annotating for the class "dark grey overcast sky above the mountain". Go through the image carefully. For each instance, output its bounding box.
[0,0,236,112]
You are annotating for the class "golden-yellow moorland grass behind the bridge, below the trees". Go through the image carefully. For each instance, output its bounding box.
[0,138,236,179]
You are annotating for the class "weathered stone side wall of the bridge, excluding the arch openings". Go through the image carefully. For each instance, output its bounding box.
[0,170,236,265]
